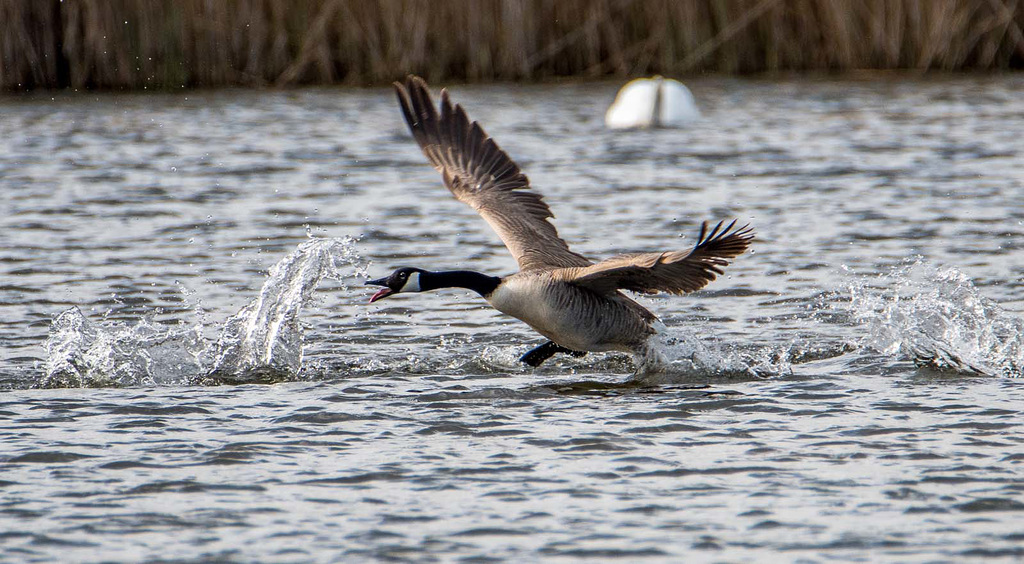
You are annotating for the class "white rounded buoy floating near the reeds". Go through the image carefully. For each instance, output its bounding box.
[604,77,700,129]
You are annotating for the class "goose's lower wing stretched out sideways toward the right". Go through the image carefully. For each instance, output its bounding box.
[552,221,754,294]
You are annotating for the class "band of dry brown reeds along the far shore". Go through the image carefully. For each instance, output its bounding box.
[6,0,1024,92]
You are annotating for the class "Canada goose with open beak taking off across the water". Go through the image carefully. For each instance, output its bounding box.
[367,76,754,366]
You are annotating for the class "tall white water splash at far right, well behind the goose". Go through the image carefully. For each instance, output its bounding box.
[845,260,1024,377]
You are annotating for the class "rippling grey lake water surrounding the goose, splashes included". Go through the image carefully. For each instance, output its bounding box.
[0,75,1024,562]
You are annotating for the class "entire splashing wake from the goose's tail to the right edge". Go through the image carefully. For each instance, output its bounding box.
[637,259,1024,384]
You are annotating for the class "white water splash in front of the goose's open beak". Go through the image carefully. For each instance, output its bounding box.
[38,237,366,388]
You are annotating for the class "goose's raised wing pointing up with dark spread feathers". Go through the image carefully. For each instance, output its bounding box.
[394,76,591,270]
